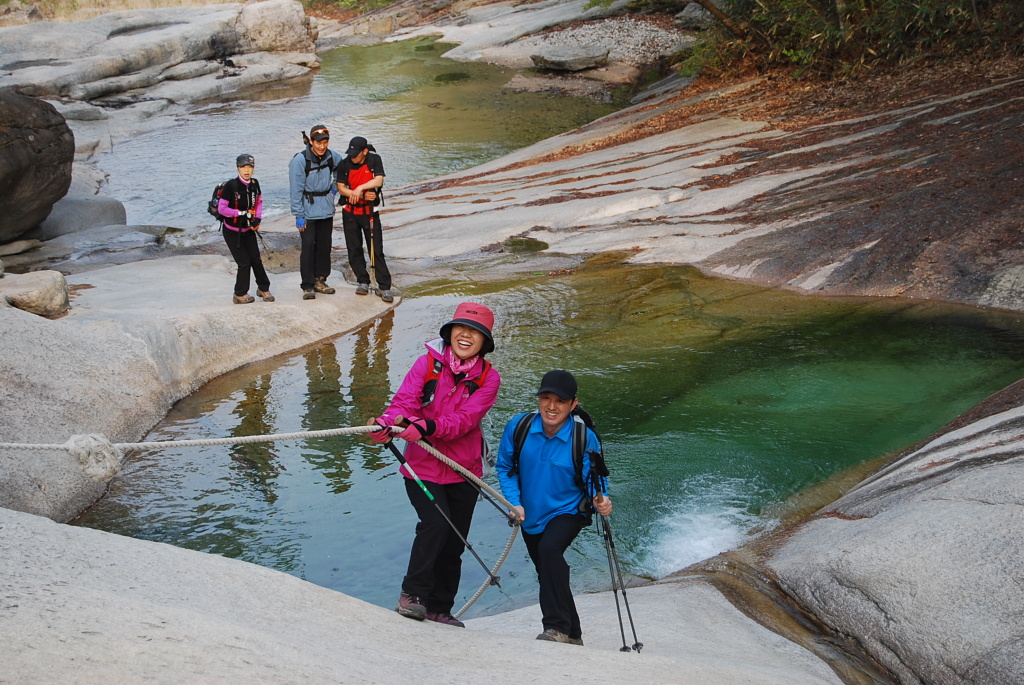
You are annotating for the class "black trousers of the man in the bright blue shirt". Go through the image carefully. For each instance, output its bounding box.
[522,514,585,638]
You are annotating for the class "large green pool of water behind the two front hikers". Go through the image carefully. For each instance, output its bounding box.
[79,258,1024,616]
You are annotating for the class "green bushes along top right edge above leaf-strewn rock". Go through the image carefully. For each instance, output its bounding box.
[614,0,1024,74]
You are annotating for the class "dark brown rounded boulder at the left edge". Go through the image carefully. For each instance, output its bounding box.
[0,90,75,243]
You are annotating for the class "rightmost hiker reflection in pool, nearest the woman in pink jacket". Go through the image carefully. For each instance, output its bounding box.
[348,309,394,471]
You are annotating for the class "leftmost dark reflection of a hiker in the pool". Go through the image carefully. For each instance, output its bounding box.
[230,374,281,504]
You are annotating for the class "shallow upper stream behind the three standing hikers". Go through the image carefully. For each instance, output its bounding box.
[96,39,615,228]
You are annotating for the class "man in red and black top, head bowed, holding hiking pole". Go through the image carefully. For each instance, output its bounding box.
[337,135,394,302]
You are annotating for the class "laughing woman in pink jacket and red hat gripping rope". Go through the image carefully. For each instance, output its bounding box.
[370,302,502,628]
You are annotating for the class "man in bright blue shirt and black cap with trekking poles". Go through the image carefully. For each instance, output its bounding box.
[496,370,611,645]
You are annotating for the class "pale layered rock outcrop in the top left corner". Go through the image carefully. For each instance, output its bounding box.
[0,0,318,153]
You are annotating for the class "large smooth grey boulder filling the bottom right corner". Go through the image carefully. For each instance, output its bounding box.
[768,382,1024,683]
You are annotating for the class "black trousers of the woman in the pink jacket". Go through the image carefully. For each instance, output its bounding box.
[401,478,476,613]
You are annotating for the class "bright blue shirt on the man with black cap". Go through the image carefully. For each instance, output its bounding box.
[496,413,608,534]
